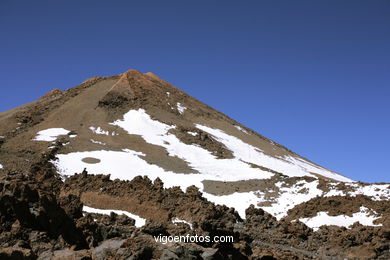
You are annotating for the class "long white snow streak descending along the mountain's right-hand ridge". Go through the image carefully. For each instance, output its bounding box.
[196,124,351,181]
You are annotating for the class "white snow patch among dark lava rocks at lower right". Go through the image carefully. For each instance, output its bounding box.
[299,206,382,230]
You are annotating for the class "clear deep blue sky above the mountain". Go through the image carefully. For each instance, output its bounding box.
[0,0,390,182]
